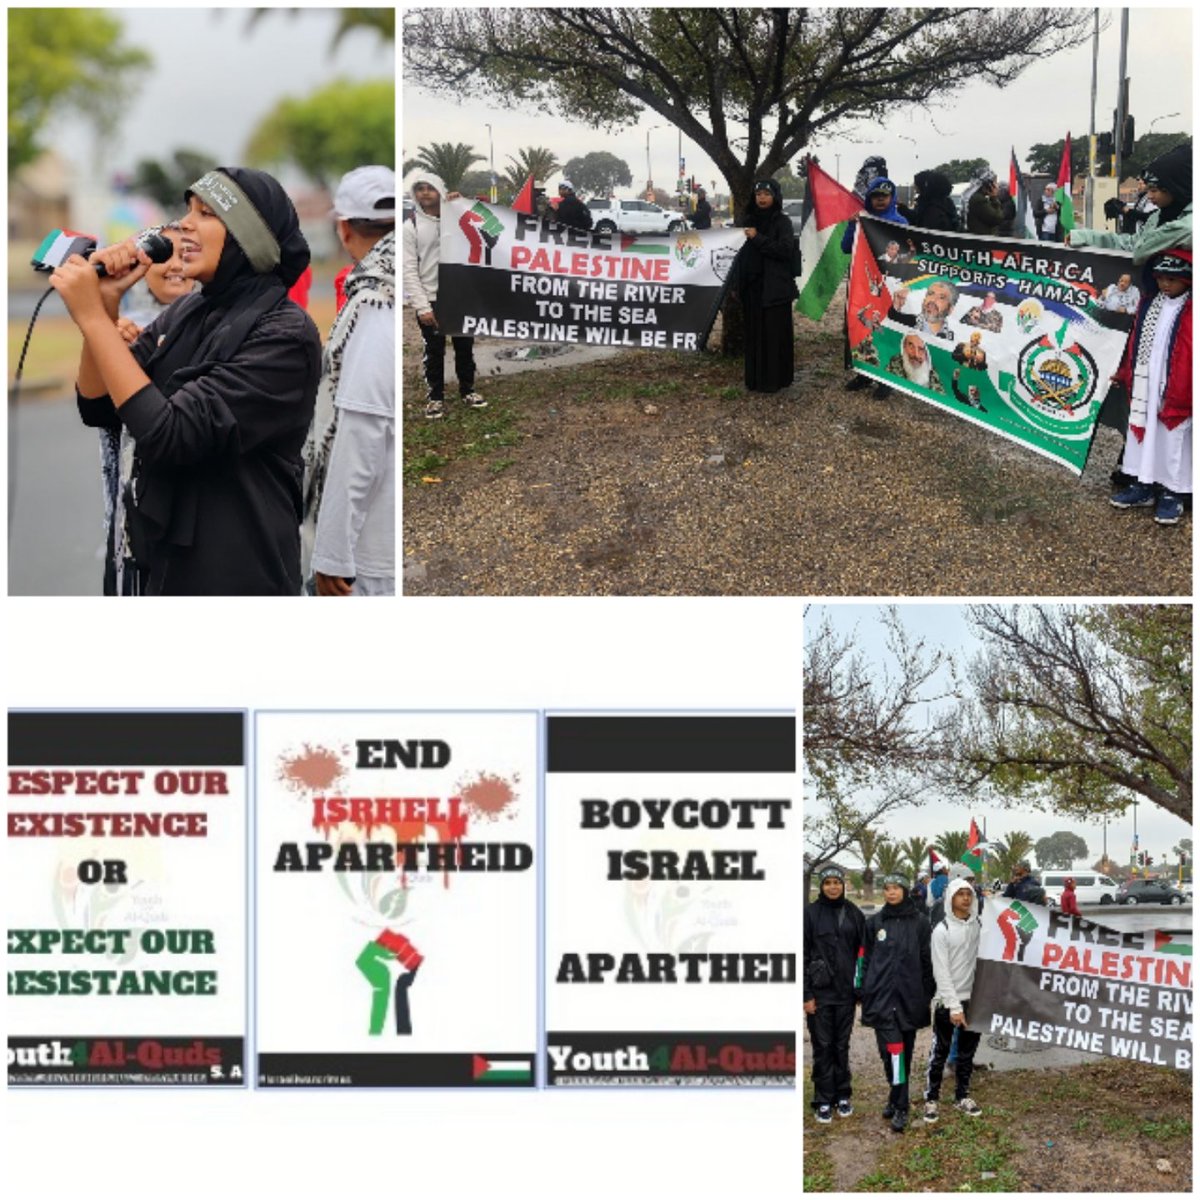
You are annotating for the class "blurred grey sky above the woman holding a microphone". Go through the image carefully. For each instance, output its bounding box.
[50,8,396,180]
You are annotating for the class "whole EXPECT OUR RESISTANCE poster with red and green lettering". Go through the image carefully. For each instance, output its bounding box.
[4,712,247,1087]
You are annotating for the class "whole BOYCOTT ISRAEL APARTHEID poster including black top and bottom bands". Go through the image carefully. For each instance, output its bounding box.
[546,714,800,1087]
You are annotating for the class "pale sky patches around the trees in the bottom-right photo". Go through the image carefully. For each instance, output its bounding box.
[804,601,1192,865]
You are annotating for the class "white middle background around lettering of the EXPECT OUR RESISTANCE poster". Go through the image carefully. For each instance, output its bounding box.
[4,763,247,1038]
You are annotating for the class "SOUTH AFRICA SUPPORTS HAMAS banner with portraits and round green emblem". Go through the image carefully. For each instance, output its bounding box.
[846,217,1133,474]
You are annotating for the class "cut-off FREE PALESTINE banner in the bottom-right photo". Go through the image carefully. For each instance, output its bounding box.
[971,898,1192,1070]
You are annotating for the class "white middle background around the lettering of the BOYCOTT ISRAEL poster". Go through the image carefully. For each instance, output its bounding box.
[546,772,800,1032]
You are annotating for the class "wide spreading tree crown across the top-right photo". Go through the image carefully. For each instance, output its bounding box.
[404,5,1092,218]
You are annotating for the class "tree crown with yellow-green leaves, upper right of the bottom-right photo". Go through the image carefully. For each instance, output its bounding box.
[946,605,1192,821]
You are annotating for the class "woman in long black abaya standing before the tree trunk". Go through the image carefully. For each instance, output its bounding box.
[738,179,798,392]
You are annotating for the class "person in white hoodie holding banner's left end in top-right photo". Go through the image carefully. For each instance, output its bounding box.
[403,167,487,421]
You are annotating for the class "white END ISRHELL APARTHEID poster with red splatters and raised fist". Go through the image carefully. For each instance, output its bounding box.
[256,713,538,1088]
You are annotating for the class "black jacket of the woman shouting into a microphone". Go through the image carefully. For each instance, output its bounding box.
[79,299,320,595]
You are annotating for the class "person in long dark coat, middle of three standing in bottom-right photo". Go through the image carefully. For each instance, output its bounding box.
[863,875,935,1133]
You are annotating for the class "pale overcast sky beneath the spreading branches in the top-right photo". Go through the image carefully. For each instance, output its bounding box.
[402,7,1192,191]
